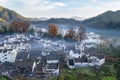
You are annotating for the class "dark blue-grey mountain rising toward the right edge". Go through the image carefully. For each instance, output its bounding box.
[83,10,120,29]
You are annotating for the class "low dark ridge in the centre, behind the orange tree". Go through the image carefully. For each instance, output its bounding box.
[30,18,81,28]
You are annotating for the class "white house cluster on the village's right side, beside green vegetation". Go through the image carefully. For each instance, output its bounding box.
[67,32,105,68]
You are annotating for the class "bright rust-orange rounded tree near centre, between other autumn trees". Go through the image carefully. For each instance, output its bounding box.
[48,24,58,37]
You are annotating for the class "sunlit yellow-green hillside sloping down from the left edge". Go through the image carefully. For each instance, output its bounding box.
[0,6,27,22]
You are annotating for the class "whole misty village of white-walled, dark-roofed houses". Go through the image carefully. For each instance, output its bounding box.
[0,32,105,80]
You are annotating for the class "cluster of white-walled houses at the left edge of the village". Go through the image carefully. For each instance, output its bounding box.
[0,35,31,62]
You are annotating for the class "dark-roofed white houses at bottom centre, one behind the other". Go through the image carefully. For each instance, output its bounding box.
[43,51,65,76]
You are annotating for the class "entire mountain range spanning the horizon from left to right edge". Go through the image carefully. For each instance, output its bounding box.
[0,6,120,29]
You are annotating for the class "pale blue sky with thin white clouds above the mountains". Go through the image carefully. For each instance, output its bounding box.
[0,0,120,18]
